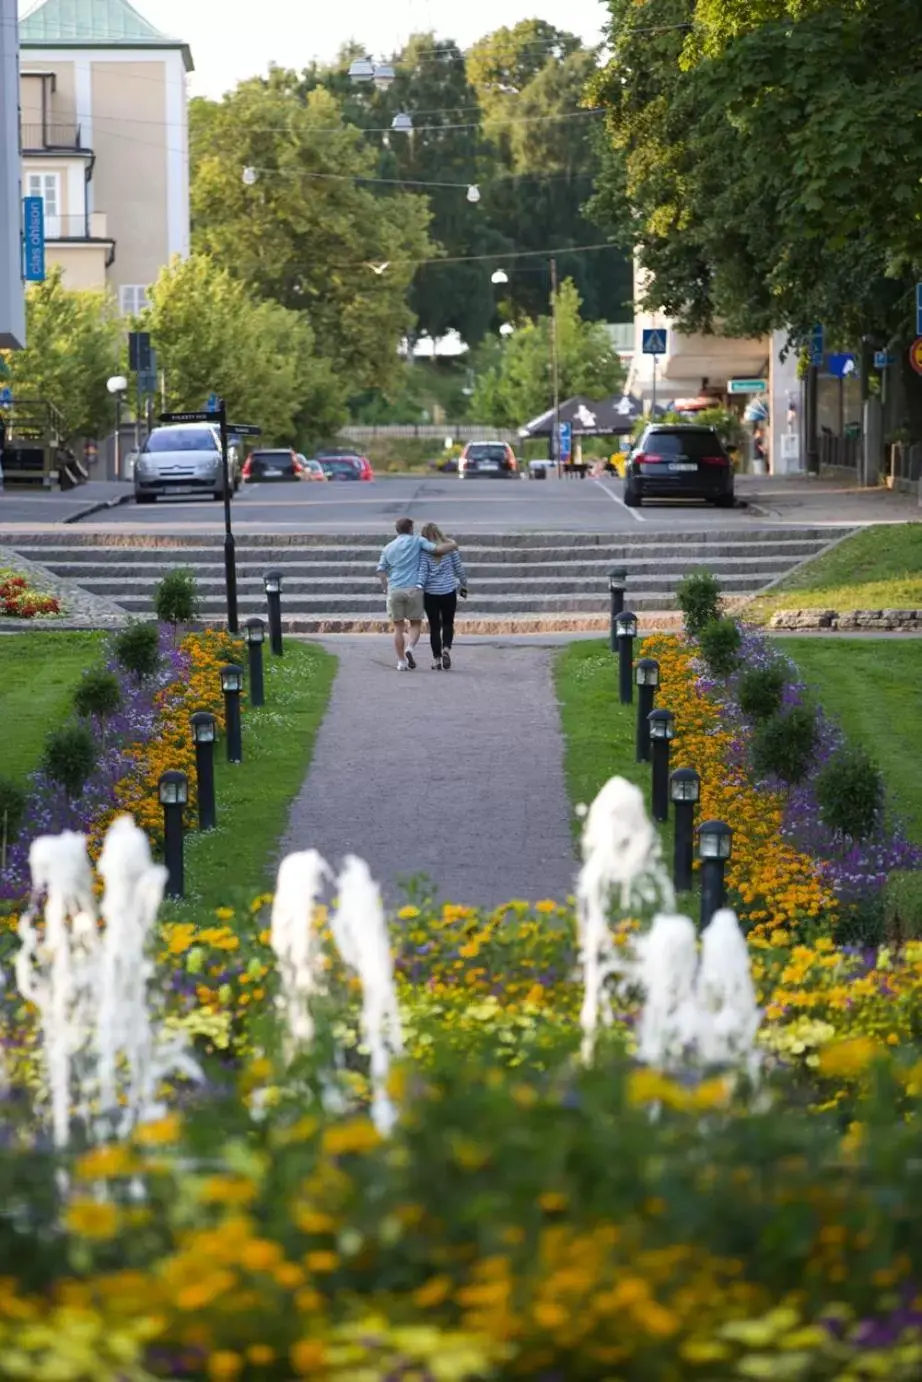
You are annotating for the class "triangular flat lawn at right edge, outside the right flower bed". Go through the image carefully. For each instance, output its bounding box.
[778,637,922,843]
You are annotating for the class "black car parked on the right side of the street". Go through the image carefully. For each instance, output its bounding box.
[625,423,734,509]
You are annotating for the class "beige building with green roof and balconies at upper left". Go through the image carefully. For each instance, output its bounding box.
[19,0,192,315]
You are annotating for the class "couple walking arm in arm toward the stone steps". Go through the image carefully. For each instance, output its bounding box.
[377,518,467,672]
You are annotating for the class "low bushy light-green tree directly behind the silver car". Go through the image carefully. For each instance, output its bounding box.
[144,254,346,445]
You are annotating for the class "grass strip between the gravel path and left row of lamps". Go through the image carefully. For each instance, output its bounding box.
[163,638,336,920]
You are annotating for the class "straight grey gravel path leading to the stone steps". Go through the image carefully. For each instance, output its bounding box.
[283,637,576,907]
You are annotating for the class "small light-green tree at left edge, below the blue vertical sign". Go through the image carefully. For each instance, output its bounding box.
[3,265,122,439]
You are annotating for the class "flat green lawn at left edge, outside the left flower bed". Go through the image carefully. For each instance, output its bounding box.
[0,630,102,782]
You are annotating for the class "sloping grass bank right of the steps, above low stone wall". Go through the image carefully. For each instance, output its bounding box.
[744,524,922,623]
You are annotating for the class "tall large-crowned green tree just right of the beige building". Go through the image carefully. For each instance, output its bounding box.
[191,69,433,388]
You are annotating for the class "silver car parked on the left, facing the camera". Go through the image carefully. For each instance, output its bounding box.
[134,423,241,504]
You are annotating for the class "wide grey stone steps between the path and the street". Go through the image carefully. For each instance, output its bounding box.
[12,528,840,633]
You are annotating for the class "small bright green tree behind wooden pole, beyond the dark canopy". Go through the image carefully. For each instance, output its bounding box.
[470,281,625,427]
